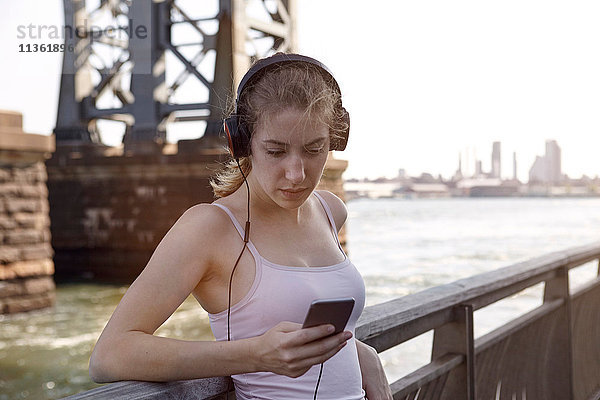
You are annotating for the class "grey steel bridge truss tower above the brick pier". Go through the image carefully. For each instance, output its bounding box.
[55,0,296,153]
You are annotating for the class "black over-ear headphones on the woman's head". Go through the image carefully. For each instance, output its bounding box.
[223,53,350,159]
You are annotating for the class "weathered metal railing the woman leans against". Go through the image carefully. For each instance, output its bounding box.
[69,242,600,400]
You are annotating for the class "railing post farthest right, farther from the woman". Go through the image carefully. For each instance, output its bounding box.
[544,265,574,399]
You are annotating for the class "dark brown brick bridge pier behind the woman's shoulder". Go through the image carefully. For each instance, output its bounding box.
[46,145,347,283]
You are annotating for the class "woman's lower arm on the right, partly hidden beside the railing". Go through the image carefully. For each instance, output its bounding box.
[356,340,392,400]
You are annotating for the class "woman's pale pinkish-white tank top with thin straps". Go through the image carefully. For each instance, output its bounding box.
[208,192,365,400]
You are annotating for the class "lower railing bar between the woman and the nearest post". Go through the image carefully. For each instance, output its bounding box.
[390,354,465,397]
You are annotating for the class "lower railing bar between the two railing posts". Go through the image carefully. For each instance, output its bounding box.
[475,299,565,354]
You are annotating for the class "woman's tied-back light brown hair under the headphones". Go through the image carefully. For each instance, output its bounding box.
[210,55,348,198]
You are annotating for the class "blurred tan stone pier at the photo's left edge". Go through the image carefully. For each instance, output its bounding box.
[0,111,55,313]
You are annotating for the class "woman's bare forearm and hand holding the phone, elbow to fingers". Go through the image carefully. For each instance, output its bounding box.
[90,322,349,383]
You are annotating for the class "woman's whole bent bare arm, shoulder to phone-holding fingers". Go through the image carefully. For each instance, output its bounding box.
[89,205,346,383]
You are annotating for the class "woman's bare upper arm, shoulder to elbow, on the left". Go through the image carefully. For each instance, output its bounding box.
[94,204,234,336]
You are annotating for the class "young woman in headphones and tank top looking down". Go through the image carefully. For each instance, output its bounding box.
[90,53,392,400]
